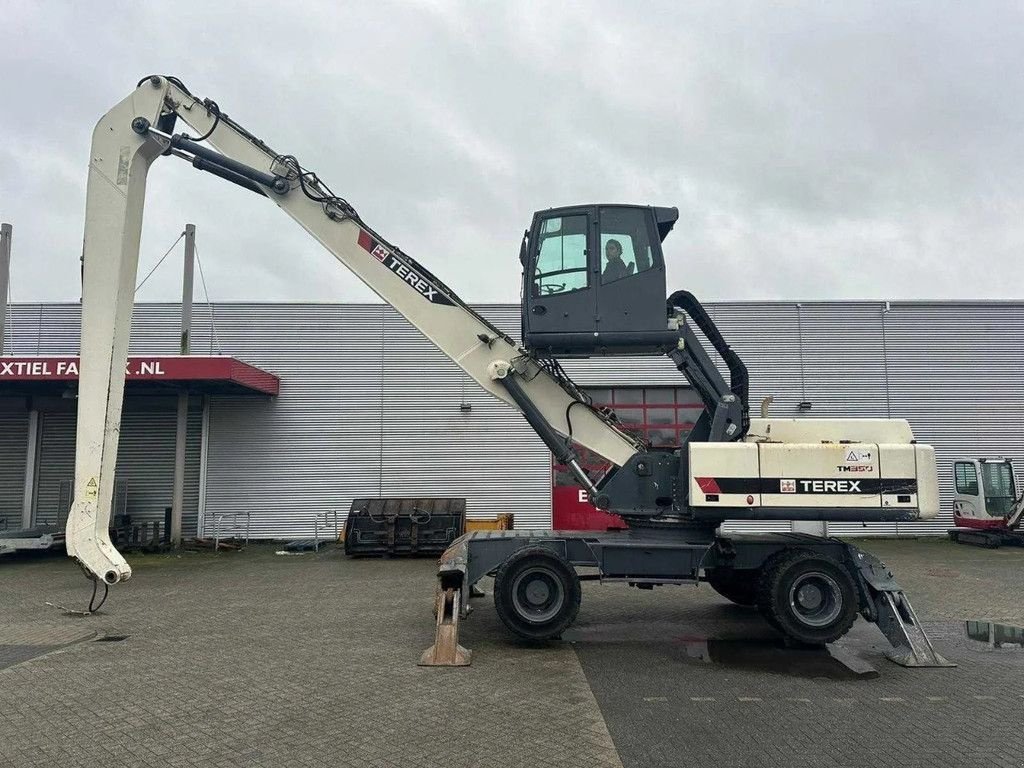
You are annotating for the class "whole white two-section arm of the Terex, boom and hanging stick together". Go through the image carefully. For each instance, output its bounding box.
[67,77,640,584]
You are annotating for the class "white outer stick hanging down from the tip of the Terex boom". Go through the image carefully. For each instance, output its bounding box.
[66,78,166,585]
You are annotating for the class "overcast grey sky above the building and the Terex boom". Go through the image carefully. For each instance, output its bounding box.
[0,0,1024,301]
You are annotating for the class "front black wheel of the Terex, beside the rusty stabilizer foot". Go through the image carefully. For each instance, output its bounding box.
[495,546,583,642]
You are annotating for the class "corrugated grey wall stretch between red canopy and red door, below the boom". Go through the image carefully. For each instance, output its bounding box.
[200,304,551,537]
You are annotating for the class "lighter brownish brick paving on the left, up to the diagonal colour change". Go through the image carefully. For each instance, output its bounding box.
[0,550,621,768]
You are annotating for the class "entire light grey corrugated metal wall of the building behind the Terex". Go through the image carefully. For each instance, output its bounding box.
[4,301,1024,537]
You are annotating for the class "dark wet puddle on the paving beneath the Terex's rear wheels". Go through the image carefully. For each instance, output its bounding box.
[677,638,879,680]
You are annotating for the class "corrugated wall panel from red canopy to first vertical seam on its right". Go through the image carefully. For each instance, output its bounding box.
[205,305,382,537]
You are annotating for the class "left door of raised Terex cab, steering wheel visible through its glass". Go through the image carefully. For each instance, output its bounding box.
[523,214,597,334]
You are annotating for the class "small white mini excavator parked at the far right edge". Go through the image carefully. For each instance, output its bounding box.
[949,458,1024,549]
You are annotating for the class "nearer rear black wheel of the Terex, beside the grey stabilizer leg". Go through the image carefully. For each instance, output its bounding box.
[758,549,860,645]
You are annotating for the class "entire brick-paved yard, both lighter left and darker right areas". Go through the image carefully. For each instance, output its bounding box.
[0,542,1024,767]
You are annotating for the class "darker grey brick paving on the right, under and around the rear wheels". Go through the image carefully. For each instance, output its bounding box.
[569,541,1024,768]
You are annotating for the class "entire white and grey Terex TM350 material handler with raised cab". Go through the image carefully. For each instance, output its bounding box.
[67,76,948,666]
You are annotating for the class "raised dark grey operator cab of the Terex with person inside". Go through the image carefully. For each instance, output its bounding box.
[519,205,679,357]
